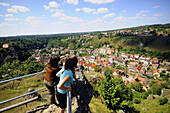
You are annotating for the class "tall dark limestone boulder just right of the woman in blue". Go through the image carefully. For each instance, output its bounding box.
[71,70,93,113]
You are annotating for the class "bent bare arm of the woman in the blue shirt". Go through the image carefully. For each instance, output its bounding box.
[57,76,71,91]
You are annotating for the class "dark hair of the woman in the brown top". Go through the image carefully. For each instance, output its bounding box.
[48,56,60,68]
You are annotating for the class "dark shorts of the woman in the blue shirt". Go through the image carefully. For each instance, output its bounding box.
[56,89,67,109]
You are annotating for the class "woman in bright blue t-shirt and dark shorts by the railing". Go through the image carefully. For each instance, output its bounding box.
[56,56,78,113]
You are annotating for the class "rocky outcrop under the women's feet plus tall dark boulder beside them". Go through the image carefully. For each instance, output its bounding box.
[27,68,93,113]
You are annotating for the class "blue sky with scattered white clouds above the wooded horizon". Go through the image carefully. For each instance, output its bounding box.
[0,0,170,37]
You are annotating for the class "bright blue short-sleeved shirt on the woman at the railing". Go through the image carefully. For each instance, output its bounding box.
[57,70,73,94]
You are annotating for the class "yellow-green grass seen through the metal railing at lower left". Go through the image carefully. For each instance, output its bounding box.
[0,74,48,113]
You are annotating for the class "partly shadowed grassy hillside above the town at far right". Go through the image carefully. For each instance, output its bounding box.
[110,36,170,52]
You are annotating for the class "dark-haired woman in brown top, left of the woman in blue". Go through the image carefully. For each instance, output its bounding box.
[44,56,60,104]
